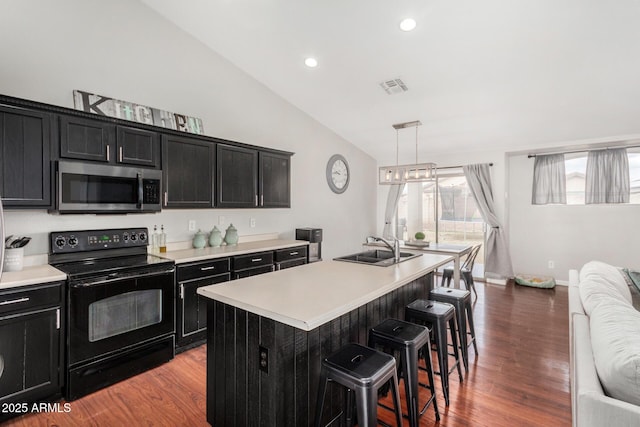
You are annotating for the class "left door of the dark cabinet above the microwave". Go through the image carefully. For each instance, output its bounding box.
[60,116,116,163]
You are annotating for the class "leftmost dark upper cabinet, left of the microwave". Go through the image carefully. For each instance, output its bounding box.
[0,105,51,208]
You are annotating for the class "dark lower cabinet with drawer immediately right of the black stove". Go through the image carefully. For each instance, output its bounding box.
[176,258,230,351]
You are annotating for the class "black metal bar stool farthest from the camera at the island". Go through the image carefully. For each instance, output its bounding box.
[429,287,478,372]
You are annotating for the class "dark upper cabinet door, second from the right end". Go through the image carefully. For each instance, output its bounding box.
[216,144,258,208]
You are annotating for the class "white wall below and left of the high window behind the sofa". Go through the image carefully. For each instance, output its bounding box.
[508,155,640,280]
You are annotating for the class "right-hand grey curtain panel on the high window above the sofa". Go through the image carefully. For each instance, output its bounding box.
[585,148,631,204]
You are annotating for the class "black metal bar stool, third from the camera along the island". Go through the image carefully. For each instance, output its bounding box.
[404,299,462,406]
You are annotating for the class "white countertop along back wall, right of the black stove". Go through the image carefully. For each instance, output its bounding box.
[161,239,309,264]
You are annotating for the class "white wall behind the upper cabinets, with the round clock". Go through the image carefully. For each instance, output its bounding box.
[0,0,376,258]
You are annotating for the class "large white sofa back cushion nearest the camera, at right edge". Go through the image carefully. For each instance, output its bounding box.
[589,299,640,405]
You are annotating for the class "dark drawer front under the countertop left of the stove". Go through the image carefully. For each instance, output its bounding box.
[0,283,62,315]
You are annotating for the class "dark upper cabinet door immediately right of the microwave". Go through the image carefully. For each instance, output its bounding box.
[162,135,216,208]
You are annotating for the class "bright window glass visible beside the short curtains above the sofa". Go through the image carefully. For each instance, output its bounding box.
[564,147,640,205]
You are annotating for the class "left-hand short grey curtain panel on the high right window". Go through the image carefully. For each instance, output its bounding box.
[531,154,567,205]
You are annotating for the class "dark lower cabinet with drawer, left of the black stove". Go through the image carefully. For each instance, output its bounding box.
[0,283,64,421]
